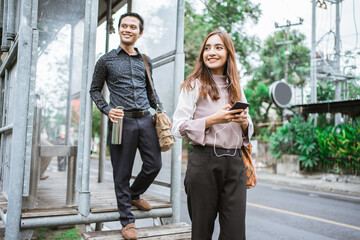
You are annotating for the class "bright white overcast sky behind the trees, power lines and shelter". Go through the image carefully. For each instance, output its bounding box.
[97,0,360,76]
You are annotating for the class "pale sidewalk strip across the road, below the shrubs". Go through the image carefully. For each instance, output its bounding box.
[256,168,360,197]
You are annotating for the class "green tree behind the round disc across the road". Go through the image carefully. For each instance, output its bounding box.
[245,30,310,126]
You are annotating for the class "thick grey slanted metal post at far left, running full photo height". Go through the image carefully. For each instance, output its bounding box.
[5,0,32,240]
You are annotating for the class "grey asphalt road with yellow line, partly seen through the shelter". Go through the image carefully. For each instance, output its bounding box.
[91,157,360,240]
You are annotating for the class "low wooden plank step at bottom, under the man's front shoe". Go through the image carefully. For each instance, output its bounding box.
[82,222,191,240]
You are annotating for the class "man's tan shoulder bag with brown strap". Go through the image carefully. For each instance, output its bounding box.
[142,54,175,152]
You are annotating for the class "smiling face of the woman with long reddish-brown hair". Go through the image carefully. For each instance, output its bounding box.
[203,34,228,75]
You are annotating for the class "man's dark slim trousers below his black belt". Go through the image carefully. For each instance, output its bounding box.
[109,114,161,226]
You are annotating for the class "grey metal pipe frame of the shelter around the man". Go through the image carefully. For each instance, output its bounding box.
[0,0,185,240]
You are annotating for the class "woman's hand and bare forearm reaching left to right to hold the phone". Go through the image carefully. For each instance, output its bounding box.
[205,104,243,128]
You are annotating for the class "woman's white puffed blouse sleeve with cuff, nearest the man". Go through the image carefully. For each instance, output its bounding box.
[172,80,207,145]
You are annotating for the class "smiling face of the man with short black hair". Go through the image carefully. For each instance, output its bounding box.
[119,16,142,45]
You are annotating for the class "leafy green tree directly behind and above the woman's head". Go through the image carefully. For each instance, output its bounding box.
[184,0,261,76]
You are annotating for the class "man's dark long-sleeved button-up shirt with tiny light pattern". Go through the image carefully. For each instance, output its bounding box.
[90,46,162,115]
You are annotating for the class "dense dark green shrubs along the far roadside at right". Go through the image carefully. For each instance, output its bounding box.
[270,116,360,173]
